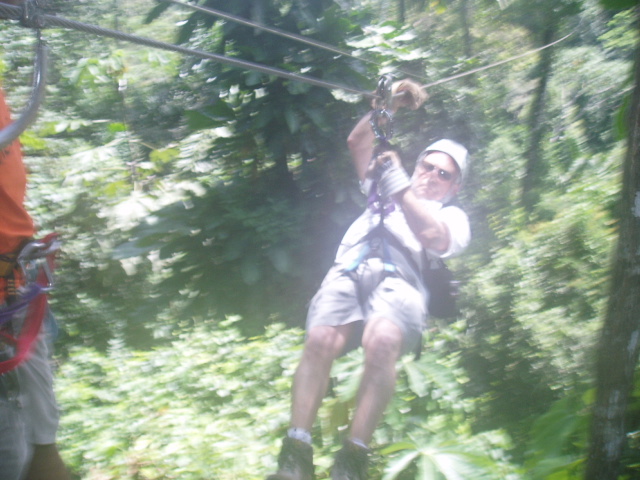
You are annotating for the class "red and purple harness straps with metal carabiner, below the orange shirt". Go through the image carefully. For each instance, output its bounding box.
[0,234,60,376]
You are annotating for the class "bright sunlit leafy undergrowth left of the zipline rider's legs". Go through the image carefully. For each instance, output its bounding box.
[57,319,300,480]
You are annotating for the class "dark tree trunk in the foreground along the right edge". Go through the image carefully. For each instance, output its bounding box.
[585,10,640,480]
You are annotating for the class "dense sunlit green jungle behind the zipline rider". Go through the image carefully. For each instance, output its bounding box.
[0,0,640,480]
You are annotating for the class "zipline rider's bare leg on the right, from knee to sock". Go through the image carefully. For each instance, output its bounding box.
[351,318,402,444]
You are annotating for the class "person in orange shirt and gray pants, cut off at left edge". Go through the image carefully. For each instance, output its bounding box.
[0,80,71,480]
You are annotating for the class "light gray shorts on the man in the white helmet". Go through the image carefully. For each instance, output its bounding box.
[306,258,427,353]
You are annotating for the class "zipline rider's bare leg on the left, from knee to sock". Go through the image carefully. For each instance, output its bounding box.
[291,324,354,431]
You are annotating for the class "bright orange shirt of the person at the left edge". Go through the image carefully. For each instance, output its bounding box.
[0,89,34,254]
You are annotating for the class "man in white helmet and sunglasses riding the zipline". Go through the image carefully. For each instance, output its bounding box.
[267,80,470,480]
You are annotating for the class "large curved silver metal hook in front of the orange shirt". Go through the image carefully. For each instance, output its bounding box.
[0,30,48,150]
